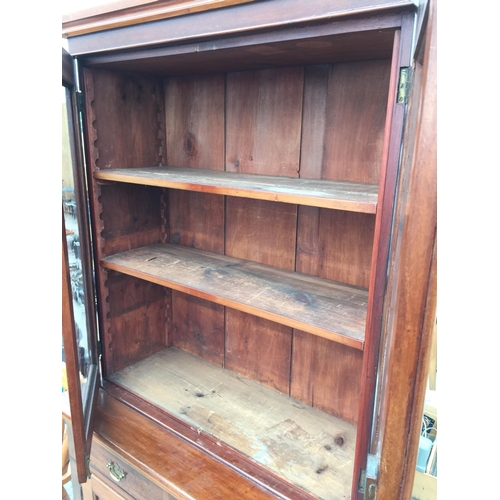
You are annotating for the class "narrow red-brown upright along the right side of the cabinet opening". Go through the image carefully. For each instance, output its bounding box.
[352,9,415,500]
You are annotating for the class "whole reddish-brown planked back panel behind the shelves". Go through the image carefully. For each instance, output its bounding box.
[91,60,390,422]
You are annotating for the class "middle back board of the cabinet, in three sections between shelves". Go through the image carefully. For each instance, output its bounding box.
[226,67,304,394]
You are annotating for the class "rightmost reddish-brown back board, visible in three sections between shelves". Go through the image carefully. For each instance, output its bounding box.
[291,60,390,422]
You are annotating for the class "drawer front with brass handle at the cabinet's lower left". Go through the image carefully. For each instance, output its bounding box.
[90,435,175,500]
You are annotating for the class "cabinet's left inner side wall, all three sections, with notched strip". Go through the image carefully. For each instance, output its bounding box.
[83,69,169,375]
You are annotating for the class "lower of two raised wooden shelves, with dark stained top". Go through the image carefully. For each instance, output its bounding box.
[102,244,368,350]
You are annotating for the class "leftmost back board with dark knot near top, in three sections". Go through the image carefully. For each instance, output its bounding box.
[164,75,225,365]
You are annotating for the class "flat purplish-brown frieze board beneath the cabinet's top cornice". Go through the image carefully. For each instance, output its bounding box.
[64,0,414,55]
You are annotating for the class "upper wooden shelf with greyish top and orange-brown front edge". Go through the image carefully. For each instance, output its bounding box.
[94,167,378,214]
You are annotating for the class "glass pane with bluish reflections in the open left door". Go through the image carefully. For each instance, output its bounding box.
[62,87,91,406]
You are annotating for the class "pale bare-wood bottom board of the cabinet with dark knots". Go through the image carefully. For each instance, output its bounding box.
[111,347,356,500]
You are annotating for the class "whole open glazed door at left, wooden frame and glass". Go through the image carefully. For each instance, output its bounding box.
[62,49,99,483]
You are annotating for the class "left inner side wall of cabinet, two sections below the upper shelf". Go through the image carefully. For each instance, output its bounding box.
[100,184,169,376]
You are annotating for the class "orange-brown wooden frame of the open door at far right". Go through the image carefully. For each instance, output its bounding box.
[373,0,437,499]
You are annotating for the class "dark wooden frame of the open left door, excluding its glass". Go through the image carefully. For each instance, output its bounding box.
[62,49,100,483]
